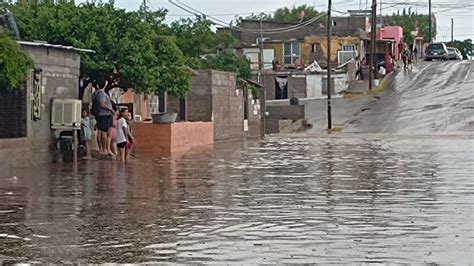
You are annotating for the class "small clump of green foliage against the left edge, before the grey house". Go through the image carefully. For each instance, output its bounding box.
[0,33,33,90]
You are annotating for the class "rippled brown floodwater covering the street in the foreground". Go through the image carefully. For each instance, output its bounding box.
[0,134,474,264]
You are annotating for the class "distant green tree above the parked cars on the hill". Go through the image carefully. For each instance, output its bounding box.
[385,8,436,45]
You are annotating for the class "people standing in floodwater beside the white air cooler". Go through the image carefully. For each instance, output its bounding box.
[81,79,134,162]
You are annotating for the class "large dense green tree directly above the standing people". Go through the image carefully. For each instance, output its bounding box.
[4,1,189,94]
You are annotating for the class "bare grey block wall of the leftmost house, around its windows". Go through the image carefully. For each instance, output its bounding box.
[0,45,80,167]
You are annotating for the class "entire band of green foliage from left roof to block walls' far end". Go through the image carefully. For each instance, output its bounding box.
[0,0,250,96]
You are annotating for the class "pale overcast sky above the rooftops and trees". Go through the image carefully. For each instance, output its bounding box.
[93,0,474,41]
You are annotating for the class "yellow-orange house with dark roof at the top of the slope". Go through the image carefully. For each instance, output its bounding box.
[227,17,367,70]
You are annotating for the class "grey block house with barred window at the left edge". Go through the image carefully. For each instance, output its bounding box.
[0,41,93,166]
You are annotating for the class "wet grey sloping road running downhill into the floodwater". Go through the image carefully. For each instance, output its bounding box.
[344,61,474,134]
